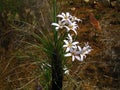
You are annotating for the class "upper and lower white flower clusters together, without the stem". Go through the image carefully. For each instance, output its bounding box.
[52,12,92,61]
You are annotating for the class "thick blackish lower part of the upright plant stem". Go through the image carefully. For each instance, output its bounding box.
[52,50,63,90]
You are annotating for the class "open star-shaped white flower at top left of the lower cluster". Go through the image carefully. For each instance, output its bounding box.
[63,34,79,52]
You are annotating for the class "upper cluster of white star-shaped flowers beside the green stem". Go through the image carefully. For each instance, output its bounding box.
[52,12,81,34]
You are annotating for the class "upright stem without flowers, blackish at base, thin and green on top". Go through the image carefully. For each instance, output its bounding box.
[51,0,63,90]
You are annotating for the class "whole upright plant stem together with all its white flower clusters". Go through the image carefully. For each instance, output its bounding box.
[51,0,92,90]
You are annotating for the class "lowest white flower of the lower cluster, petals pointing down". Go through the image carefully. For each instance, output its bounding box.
[64,48,81,61]
